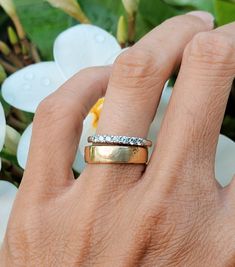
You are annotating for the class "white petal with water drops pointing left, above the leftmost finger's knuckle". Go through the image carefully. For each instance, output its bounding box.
[2,61,64,112]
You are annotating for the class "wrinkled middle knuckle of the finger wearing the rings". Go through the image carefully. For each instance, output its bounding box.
[111,48,164,92]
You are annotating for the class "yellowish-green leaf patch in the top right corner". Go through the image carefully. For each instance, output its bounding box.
[214,0,235,26]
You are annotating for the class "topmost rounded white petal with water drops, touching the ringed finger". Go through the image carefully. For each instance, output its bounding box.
[54,24,121,78]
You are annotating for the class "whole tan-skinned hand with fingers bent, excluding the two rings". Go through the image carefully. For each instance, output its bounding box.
[0,12,235,267]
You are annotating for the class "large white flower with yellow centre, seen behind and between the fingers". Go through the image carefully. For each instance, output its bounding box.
[2,25,235,185]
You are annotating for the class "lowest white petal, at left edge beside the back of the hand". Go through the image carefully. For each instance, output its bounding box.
[0,180,17,244]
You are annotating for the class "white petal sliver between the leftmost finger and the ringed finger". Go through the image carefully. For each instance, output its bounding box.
[73,113,95,173]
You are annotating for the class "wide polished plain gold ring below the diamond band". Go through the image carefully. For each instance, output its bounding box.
[85,145,148,164]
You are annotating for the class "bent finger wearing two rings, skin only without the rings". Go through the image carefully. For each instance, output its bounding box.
[83,12,213,185]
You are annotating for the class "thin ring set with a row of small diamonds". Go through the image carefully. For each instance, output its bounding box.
[88,135,151,146]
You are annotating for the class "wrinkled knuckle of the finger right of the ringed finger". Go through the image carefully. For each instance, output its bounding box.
[185,31,234,66]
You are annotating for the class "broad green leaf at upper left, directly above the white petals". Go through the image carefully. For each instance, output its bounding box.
[14,0,73,60]
